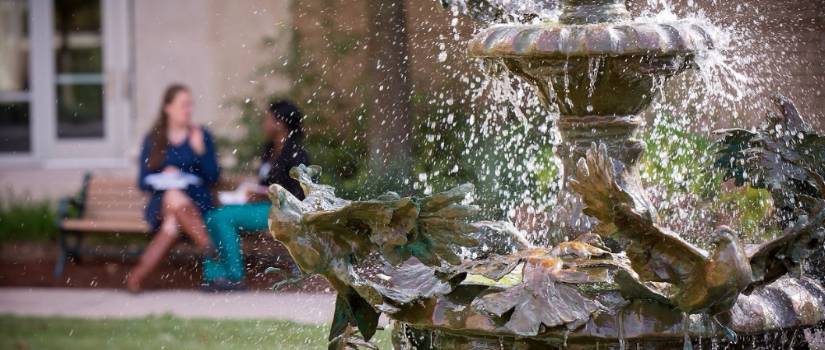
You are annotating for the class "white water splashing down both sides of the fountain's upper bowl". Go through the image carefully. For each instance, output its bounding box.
[416,0,816,243]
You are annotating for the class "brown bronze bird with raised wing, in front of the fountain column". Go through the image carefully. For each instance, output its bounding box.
[571,144,752,313]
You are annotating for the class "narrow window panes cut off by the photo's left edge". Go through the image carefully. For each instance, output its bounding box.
[0,0,32,153]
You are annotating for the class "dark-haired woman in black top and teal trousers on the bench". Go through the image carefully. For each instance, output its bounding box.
[204,101,309,290]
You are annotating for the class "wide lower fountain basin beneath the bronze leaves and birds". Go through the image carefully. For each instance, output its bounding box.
[395,277,825,349]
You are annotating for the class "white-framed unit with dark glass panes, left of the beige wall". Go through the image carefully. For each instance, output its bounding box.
[0,0,133,168]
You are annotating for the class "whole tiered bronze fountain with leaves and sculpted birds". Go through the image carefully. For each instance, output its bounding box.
[270,0,825,349]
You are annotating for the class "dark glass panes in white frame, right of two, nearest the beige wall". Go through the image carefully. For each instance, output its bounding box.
[54,0,104,139]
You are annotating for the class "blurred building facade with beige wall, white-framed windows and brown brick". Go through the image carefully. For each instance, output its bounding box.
[0,0,825,198]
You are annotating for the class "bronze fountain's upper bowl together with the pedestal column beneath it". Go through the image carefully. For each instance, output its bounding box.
[470,0,712,241]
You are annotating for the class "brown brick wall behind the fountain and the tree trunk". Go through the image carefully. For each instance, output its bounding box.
[294,0,825,130]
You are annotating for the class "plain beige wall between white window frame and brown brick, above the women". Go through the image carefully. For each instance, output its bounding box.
[130,0,292,156]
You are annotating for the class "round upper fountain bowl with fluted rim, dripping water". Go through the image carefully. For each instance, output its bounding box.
[469,21,713,116]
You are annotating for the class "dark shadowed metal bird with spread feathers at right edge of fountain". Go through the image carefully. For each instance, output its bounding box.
[716,95,825,292]
